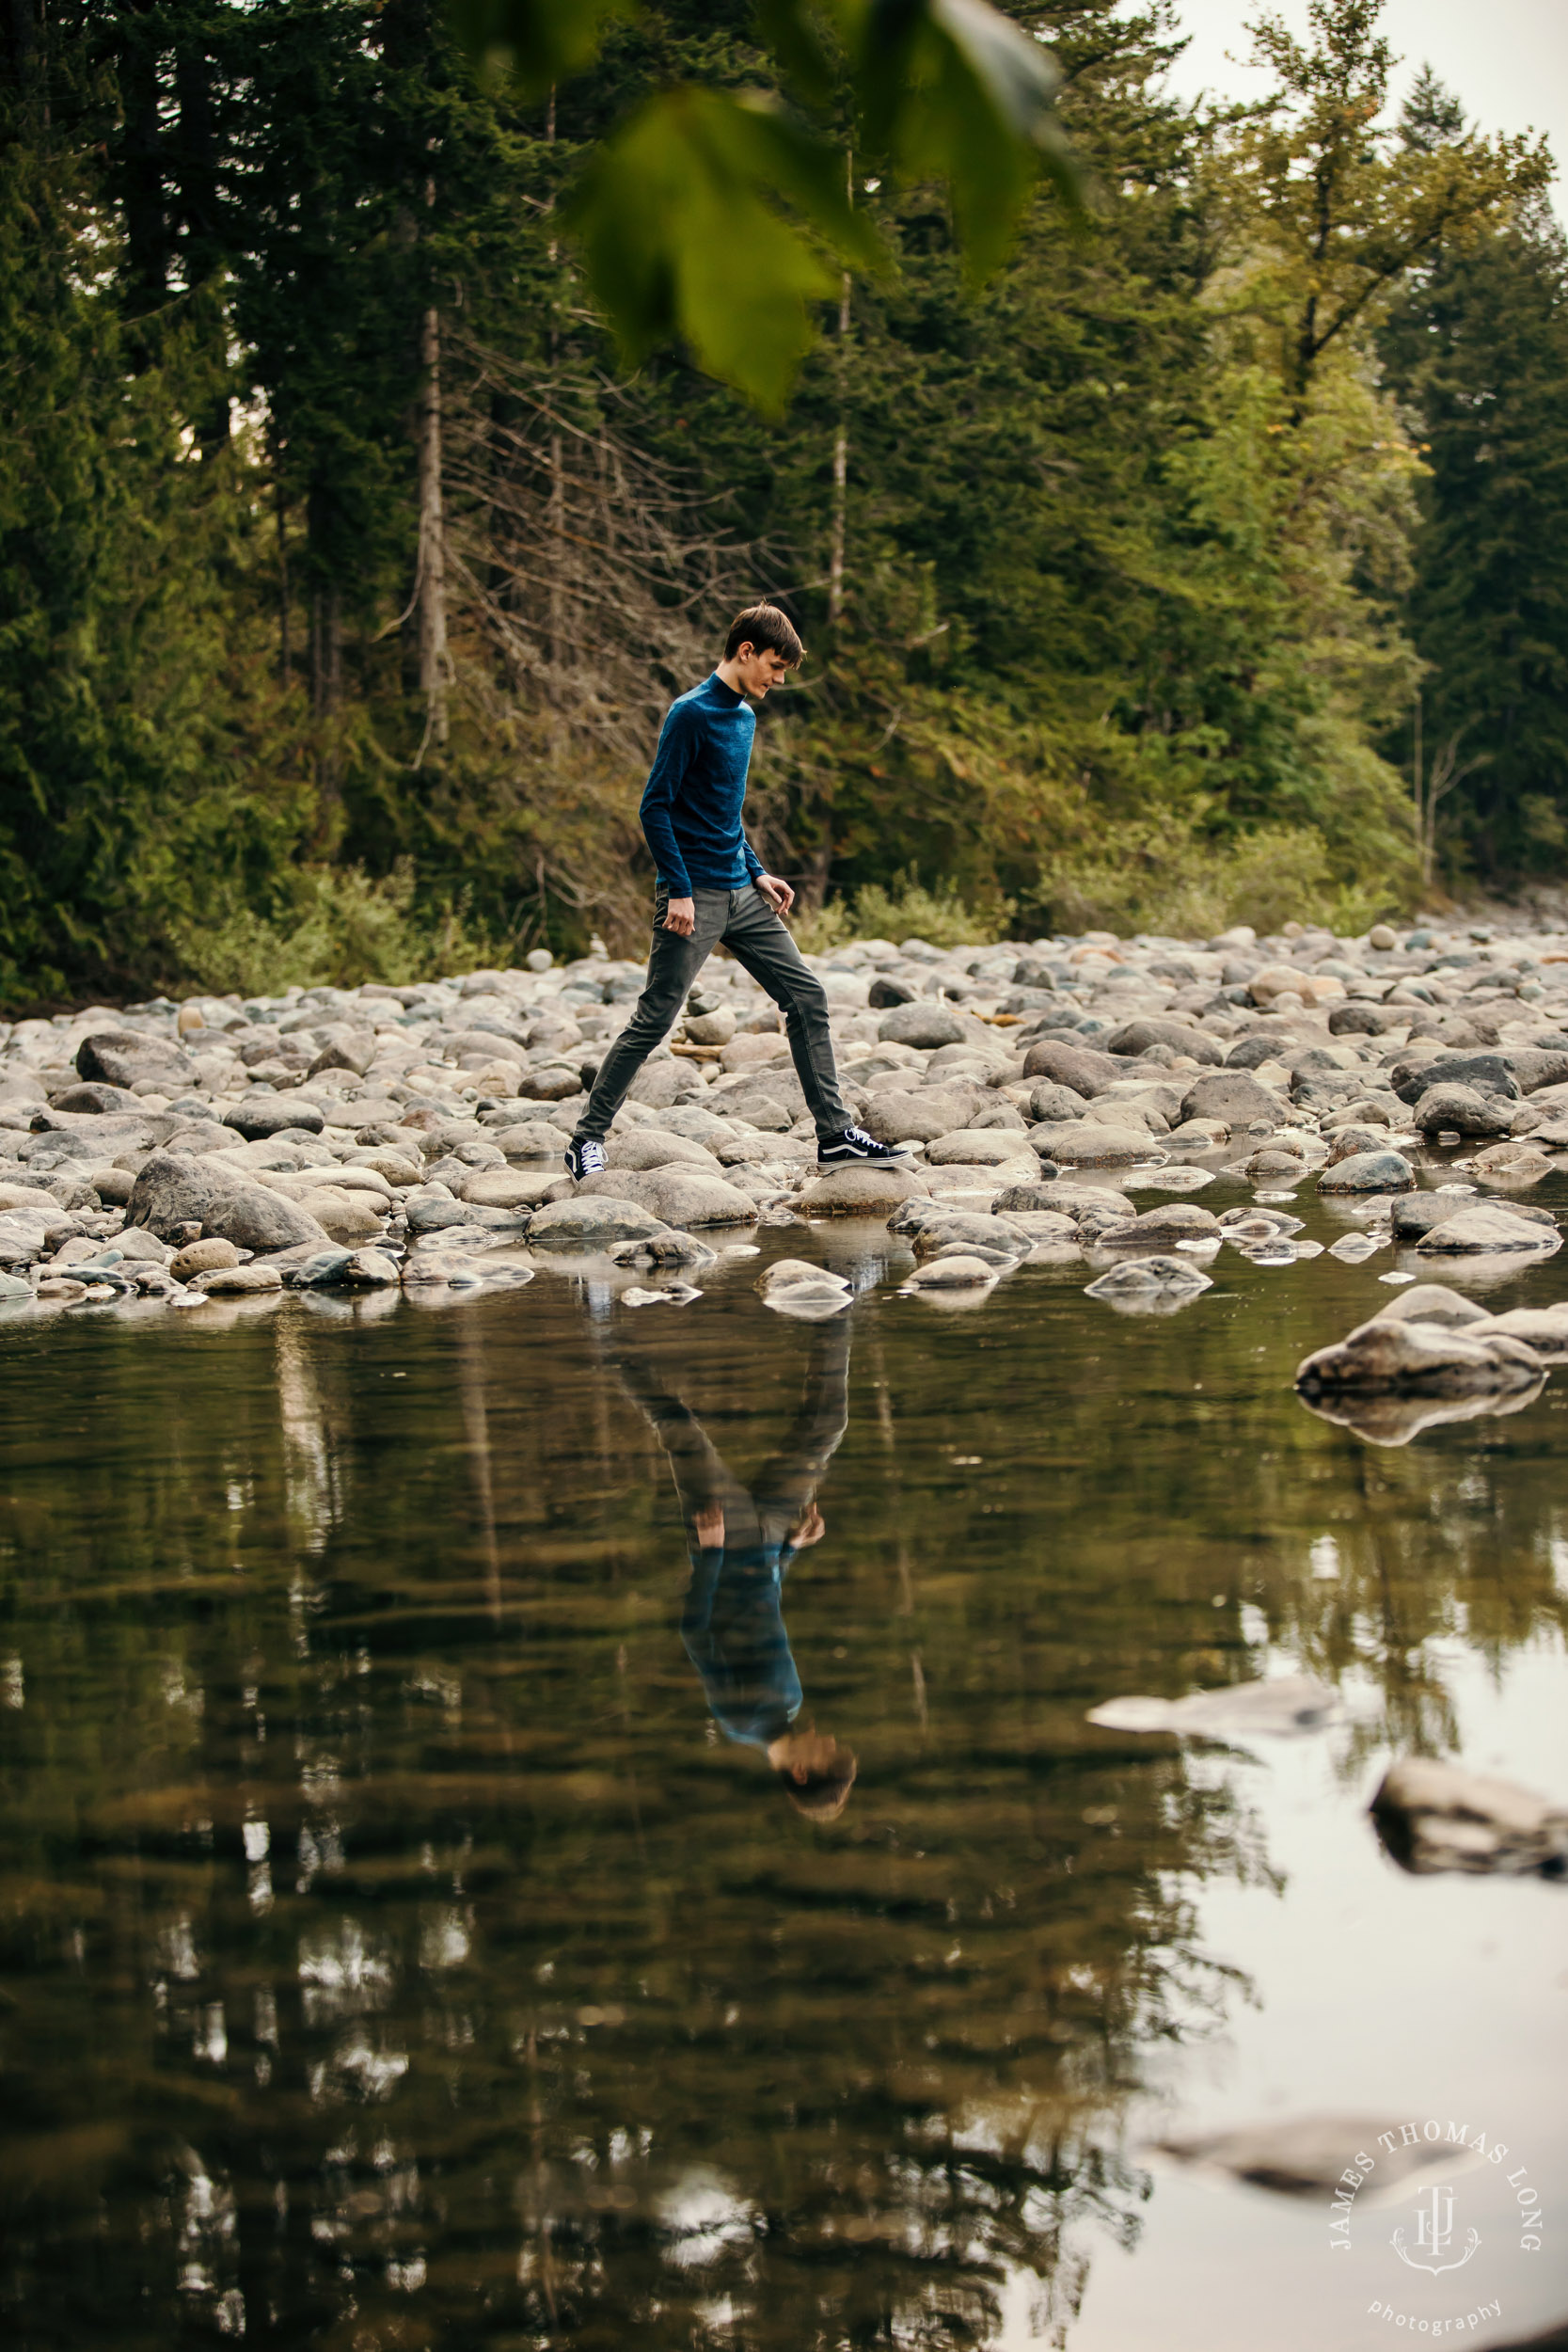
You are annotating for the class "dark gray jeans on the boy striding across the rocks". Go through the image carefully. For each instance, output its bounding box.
[576,882,848,1141]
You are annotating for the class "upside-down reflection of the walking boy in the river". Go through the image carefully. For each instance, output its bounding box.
[621,1320,856,1820]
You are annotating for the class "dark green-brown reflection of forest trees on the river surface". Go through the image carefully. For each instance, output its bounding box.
[0,1279,1557,2347]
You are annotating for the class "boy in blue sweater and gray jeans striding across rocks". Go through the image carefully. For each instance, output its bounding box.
[566,605,898,1176]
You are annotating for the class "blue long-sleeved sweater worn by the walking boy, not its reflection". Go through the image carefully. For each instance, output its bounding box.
[640,671,764,898]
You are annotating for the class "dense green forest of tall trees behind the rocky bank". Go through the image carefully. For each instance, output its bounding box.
[0,0,1568,1009]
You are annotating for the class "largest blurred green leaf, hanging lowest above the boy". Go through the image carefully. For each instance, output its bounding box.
[566,87,881,412]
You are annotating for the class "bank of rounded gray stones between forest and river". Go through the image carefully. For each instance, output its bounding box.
[0,925,1568,1374]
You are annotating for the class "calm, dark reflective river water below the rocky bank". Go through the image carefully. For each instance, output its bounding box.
[0,1179,1568,2352]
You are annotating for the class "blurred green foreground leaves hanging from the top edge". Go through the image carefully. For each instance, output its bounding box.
[449,0,1079,412]
